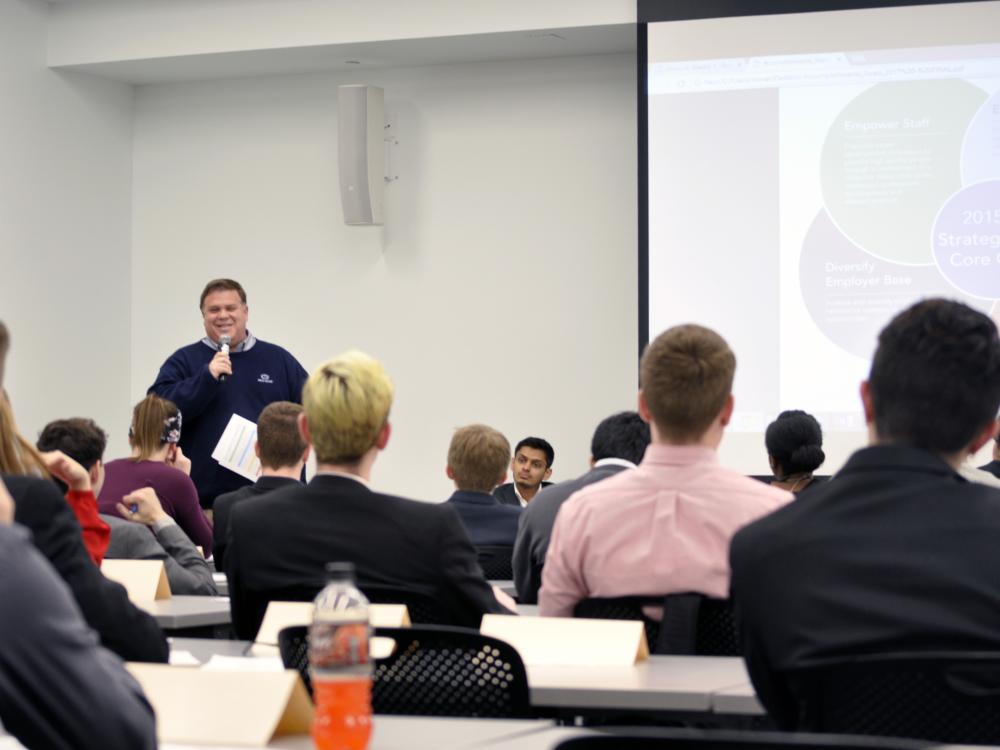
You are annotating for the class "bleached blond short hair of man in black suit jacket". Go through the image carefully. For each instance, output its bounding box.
[302,351,393,464]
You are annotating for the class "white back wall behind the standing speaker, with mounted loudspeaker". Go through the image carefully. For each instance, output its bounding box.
[131,55,638,499]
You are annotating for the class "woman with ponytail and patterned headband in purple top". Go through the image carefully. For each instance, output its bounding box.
[97,395,212,557]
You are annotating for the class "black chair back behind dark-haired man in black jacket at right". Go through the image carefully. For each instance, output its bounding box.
[785,651,1000,744]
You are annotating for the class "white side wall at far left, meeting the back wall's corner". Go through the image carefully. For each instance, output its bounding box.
[0,0,132,458]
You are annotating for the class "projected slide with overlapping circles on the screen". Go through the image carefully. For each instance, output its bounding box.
[648,31,1000,431]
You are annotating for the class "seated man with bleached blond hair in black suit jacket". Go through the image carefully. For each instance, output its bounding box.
[226,351,507,638]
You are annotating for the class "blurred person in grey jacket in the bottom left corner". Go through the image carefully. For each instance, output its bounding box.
[0,478,156,750]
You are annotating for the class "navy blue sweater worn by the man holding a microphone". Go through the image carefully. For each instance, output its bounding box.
[148,339,308,508]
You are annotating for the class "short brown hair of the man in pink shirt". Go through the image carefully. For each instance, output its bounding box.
[639,323,736,441]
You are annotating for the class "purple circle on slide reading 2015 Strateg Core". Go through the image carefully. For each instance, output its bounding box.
[931,180,1000,299]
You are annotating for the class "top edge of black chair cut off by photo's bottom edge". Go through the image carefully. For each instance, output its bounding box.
[554,727,927,750]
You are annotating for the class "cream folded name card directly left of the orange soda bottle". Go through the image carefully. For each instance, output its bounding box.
[127,662,313,747]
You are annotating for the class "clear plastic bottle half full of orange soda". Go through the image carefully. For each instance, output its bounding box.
[309,563,372,750]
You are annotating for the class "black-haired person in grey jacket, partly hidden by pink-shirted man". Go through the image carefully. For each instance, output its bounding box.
[513,411,649,604]
